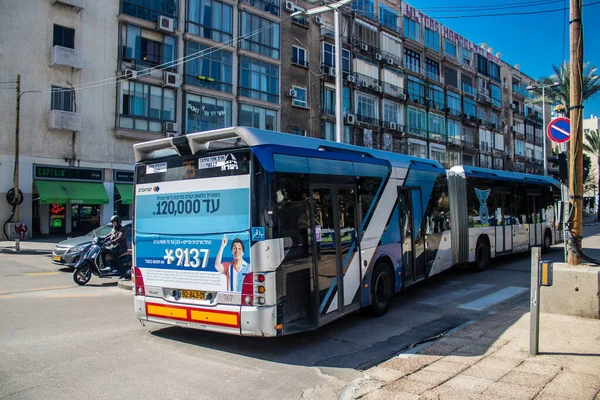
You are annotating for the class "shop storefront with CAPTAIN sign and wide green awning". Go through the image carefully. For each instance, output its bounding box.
[33,164,109,235]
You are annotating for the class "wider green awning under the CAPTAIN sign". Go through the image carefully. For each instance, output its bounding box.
[34,180,108,204]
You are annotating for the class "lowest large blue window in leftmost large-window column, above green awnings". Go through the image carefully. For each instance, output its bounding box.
[119,81,176,132]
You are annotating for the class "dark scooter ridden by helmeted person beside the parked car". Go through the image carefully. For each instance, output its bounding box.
[73,235,132,286]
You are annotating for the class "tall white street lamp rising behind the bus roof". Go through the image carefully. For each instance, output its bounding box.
[290,0,352,143]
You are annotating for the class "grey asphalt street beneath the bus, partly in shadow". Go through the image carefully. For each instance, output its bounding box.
[0,226,600,399]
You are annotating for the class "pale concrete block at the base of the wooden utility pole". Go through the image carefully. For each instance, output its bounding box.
[540,263,600,319]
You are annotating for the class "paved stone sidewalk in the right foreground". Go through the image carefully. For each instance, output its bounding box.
[340,307,600,400]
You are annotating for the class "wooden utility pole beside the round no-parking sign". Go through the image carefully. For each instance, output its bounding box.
[567,0,583,265]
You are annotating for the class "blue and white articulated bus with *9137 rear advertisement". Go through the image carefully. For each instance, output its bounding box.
[132,127,555,337]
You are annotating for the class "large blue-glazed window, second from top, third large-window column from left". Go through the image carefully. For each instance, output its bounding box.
[240,11,280,60]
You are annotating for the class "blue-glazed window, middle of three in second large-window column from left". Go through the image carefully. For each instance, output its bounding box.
[184,41,233,93]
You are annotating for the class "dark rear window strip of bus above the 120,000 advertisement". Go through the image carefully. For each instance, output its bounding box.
[135,151,250,184]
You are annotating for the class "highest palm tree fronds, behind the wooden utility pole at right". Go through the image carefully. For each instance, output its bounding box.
[532,61,600,109]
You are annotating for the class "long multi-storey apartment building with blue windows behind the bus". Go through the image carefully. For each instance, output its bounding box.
[0,0,544,235]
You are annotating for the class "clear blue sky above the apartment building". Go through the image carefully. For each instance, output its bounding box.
[407,0,600,118]
